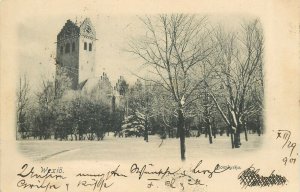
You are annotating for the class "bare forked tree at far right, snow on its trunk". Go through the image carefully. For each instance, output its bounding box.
[206,20,263,148]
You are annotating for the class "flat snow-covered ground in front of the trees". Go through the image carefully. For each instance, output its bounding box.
[17,134,263,161]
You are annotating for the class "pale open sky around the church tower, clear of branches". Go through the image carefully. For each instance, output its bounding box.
[18,14,251,90]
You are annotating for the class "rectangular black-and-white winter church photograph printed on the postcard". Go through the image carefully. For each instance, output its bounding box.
[16,14,265,160]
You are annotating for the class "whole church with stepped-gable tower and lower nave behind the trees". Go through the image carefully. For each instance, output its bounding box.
[56,18,128,106]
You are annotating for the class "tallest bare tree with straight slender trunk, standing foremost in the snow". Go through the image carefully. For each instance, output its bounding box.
[130,14,213,160]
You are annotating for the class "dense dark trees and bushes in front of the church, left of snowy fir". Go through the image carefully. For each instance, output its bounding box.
[17,70,124,140]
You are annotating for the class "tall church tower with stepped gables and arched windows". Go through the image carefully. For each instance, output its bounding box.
[56,18,96,90]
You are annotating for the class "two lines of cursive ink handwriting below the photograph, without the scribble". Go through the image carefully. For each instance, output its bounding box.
[17,160,240,192]
